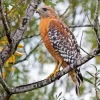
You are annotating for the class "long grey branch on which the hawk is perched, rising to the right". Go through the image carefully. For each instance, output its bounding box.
[12,48,100,94]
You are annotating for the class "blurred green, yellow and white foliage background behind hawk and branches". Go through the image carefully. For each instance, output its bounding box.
[0,0,100,100]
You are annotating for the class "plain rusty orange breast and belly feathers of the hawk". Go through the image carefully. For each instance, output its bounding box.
[39,18,61,59]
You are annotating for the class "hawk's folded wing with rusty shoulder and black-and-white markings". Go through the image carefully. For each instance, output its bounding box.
[48,20,80,64]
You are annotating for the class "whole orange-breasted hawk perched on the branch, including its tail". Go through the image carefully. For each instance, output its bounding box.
[36,6,83,94]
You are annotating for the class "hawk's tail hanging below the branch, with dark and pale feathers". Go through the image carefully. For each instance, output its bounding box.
[69,68,83,95]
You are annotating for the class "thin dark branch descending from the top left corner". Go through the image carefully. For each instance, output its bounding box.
[0,0,11,43]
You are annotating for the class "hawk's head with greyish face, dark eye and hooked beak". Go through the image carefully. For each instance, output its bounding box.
[36,6,57,18]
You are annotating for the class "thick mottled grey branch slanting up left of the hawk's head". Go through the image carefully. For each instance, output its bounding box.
[0,0,40,68]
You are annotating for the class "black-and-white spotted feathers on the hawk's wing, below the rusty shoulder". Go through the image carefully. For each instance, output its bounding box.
[48,22,79,64]
